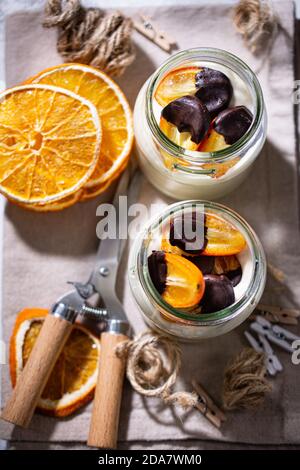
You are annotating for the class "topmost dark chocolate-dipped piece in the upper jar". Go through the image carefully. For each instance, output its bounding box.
[195,67,233,117]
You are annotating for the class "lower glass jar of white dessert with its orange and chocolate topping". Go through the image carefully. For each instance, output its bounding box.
[129,201,266,341]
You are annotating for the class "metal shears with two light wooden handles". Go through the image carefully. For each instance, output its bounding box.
[1,165,140,448]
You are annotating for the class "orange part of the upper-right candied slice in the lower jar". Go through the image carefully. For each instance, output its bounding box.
[202,213,246,256]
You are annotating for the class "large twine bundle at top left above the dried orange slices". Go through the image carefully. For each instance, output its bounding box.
[43,0,135,76]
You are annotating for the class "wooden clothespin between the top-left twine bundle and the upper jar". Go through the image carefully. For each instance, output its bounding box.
[133,14,176,52]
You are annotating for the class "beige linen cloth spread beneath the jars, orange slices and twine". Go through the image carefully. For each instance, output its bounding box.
[0,1,300,448]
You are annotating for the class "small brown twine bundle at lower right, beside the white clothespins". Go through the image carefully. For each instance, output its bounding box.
[223,348,272,410]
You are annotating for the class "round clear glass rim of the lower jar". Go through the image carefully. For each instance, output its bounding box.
[137,200,266,326]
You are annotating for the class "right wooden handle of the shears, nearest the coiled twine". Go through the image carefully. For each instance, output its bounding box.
[88,333,128,449]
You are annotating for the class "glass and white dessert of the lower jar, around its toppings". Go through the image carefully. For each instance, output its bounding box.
[128,200,266,341]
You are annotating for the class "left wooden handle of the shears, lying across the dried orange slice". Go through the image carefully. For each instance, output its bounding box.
[1,314,72,427]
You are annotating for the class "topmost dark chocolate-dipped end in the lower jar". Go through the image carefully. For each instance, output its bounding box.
[169,212,207,255]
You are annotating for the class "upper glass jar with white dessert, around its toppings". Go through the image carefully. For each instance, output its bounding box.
[134,48,267,200]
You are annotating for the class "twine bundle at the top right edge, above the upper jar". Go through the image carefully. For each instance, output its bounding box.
[233,0,278,53]
